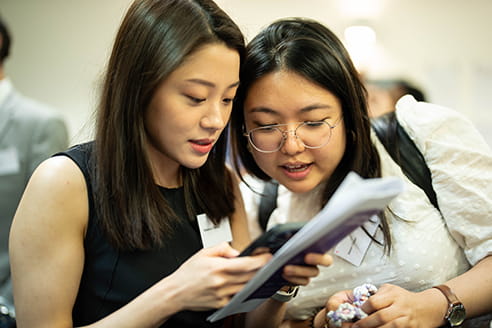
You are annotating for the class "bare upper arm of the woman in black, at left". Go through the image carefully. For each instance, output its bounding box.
[9,157,88,327]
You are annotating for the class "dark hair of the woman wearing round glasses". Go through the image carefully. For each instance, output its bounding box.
[231,18,390,249]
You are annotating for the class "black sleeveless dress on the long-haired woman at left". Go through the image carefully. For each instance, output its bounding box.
[55,142,224,328]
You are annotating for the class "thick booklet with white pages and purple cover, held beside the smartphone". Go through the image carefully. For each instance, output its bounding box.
[207,172,404,322]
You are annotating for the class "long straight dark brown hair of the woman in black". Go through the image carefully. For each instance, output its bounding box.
[94,0,245,249]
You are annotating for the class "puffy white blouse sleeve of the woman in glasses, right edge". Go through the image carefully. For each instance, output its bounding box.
[396,96,492,265]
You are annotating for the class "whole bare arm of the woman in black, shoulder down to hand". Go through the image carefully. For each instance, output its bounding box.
[10,157,269,328]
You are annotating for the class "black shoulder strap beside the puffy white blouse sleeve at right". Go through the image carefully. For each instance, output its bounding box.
[371,112,439,210]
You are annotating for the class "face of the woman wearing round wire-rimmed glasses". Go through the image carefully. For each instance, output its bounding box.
[244,71,346,193]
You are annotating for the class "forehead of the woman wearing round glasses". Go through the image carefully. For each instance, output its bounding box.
[244,71,342,115]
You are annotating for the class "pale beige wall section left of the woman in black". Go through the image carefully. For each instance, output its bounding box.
[0,0,130,144]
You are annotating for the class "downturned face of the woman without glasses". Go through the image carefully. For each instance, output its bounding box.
[145,44,240,185]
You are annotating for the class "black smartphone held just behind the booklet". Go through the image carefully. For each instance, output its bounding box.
[239,222,305,256]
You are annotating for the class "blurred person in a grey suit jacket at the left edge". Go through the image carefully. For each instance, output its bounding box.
[0,17,68,312]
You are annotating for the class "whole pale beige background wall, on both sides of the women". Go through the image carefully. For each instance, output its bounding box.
[0,0,492,144]
